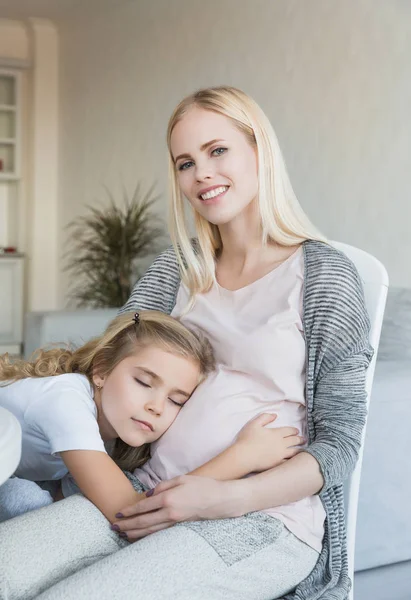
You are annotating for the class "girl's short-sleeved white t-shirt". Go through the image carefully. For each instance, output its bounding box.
[0,373,106,481]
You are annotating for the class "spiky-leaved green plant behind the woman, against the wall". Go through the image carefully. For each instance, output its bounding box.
[65,185,165,308]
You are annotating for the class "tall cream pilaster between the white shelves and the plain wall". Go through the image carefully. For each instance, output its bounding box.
[28,19,60,310]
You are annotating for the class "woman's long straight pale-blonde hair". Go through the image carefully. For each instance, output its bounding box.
[167,86,326,301]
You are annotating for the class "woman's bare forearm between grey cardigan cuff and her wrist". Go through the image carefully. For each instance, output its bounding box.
[235,452,324,514]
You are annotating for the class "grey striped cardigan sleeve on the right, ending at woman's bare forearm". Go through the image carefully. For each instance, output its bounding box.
[306,248,373,491]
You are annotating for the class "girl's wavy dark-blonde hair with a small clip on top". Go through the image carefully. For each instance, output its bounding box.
[0,310,215,471]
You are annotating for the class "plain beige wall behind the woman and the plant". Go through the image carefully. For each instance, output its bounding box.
[59,0,411,302]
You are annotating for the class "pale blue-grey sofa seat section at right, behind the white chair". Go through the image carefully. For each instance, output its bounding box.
[355,358,411,570]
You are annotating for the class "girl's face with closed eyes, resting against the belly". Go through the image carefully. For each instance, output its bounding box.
[93,346,200,447]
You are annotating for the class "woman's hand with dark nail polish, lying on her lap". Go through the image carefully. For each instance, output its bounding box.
[112,475,248,541]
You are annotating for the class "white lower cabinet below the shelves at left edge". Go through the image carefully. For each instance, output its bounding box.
[0,254,24,354]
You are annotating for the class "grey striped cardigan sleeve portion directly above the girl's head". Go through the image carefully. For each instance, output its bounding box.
[119,247,180,314]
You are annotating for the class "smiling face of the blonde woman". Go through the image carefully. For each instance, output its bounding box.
[171,107,258,225]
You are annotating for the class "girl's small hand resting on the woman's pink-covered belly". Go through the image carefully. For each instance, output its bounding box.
[234,413,304,473]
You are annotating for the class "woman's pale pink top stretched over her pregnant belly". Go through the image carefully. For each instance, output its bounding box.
[135,248,325,552]
